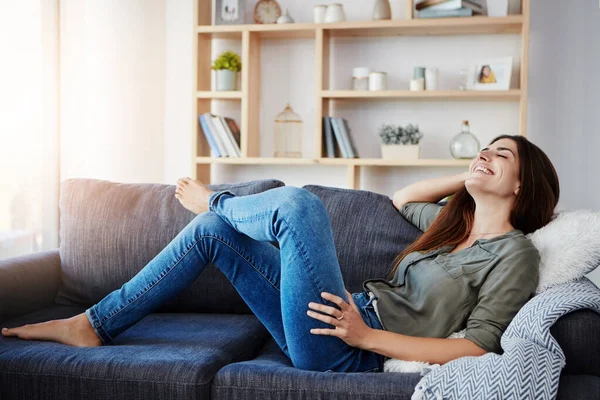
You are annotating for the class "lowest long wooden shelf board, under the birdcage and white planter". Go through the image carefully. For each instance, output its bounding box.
[196,157,471,167]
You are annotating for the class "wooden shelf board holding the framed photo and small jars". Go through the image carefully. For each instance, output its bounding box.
[321,89,521,101]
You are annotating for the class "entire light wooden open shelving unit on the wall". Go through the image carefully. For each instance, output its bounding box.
[190,0,531,189]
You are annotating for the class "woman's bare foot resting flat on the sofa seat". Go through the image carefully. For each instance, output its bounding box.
[2,313,102,347]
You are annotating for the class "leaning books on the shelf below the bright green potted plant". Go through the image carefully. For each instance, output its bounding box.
[198,113,242,157]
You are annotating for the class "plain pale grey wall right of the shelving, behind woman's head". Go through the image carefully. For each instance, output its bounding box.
[529,0,600,286]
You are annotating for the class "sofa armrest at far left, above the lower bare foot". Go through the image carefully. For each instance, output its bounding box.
[0,249,61,323]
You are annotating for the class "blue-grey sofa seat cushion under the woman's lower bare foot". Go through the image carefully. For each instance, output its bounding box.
[0,306,268,400]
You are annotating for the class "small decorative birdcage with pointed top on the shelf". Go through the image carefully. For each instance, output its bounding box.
[275,104,302,157]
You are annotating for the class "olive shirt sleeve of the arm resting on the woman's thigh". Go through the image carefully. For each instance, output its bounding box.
[465,246,540,354]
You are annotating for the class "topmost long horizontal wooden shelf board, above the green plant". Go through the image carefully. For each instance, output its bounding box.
[197,15,523,38]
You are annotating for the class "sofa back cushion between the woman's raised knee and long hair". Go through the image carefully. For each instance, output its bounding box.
[304,185,422,292]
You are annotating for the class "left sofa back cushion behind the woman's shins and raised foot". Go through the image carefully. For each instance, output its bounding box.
[56,179,284,313]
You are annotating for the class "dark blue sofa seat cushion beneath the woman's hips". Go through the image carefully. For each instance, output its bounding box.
[211,340,421,400]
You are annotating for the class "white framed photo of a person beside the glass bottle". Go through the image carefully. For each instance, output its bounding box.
[467,57,512,90]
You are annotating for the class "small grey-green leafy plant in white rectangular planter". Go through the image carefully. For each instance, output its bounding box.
[379,124,423,160]
